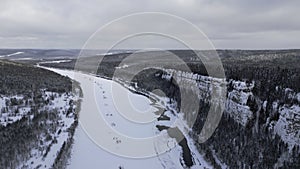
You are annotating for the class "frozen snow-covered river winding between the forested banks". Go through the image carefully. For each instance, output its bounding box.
[46,69,212,169]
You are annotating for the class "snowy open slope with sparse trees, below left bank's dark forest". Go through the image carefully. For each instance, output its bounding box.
[0,91,79,168]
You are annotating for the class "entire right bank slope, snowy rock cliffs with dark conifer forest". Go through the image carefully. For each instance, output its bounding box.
[134,69,300,168]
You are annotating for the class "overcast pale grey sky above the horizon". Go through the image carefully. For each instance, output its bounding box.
[0,0,300,49]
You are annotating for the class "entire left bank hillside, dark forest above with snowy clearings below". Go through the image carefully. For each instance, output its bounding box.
[0,60,80,169]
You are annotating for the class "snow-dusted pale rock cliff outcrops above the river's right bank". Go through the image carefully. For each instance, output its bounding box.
[161,70,300,146]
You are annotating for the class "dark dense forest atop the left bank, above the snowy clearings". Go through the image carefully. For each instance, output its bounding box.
[0,60,72,95]
